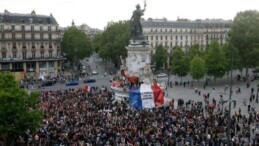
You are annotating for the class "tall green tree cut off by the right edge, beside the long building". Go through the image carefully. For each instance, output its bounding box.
[229,10,259,75]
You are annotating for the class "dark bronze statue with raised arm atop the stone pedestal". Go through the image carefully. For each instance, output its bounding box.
[130,2,146,40]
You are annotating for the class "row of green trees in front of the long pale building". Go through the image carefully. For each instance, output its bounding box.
[152,40,242,80]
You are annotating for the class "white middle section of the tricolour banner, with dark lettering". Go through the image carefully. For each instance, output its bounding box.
[140,84,155,108]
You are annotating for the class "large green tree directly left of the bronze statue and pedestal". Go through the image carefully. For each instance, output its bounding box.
[98,21,130,67]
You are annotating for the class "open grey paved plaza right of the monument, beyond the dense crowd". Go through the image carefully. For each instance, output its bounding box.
[161,71,259,115]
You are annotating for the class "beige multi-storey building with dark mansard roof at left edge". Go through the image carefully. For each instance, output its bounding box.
[0,10,65,79]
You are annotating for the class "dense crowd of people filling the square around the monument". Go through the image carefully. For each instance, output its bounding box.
[11,82,259,146]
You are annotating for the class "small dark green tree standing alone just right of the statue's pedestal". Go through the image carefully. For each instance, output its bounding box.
[151,44,168,70]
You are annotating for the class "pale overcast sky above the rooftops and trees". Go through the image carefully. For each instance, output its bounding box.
[0,0,259,30]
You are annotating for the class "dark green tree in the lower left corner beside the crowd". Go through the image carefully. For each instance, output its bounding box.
[0,73,42,145]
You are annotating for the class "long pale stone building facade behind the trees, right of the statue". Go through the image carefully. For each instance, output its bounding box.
[142,18,232,54]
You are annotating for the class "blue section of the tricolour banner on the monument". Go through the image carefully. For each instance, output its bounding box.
[129,88,142,108]
